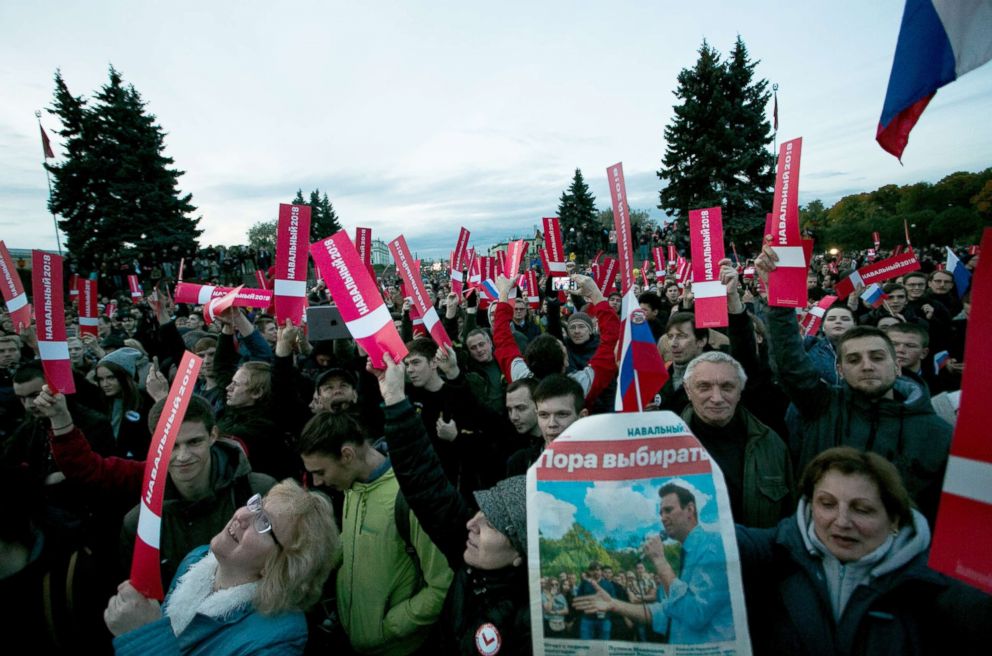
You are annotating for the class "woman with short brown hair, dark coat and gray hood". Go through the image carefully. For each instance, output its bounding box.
[737,447,990,654]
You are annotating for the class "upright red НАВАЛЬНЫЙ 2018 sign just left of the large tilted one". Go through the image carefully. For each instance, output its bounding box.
[272,204,310,326]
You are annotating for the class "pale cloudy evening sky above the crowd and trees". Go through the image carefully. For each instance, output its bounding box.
[0,0,992,255]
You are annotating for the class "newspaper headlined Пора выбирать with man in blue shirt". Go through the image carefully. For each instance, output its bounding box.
[527,412,751,656]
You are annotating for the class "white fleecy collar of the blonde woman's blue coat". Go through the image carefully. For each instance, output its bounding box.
[165,552,258,636]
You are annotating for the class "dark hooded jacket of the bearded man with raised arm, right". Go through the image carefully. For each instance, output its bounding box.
[768,308,952,525]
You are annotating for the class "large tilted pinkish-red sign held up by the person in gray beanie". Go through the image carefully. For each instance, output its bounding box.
[310,230,408,369]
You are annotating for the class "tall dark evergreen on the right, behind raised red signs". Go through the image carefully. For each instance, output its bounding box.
[658,37,775,249]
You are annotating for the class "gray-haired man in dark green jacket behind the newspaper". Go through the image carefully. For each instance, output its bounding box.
[682,351,793,528]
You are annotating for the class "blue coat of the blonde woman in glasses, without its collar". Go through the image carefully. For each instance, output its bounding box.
[114,546,307,656]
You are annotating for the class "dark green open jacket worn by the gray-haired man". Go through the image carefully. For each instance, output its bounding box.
[682,405,796,528]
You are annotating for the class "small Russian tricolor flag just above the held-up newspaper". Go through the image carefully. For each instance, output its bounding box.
[615,290,668,412]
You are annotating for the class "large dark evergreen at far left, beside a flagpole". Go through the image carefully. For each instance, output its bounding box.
[46,67,202,271]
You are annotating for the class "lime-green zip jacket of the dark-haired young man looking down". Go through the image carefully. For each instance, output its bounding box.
[337,467,452,655]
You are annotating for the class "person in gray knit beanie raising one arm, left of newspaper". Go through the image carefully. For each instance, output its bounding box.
[374,355,531,654]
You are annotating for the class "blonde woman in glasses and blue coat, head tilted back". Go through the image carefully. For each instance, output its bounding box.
[104,479,340,656]
